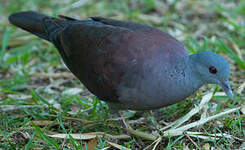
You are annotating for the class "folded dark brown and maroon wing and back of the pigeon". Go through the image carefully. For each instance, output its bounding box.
[54,18,186,102]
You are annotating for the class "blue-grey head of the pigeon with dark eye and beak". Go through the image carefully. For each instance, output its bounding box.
[190,51,233,99]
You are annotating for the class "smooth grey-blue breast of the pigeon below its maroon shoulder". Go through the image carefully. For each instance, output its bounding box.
[117,55,191,110]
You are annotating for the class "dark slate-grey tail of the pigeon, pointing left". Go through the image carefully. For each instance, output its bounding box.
[9,11,65,42]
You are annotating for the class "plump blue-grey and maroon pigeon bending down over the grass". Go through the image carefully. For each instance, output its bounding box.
[9,11,233,110]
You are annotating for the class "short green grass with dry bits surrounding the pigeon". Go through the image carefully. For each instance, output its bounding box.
[0,0,245,150]
